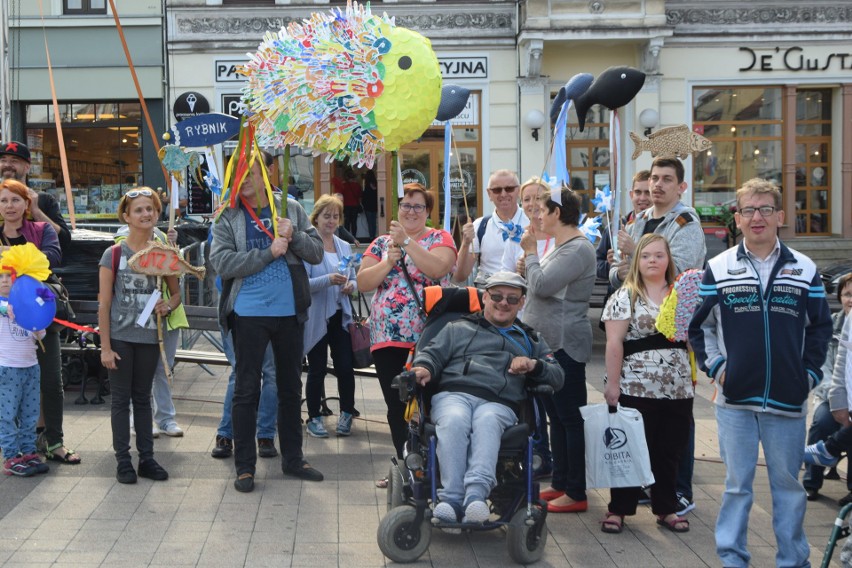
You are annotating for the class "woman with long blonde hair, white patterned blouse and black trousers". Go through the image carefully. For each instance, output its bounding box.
[601,234,695,533]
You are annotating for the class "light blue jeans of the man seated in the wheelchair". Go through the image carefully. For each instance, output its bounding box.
[432,392,518,506]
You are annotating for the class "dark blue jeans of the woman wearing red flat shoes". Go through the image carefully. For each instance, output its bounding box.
[544,349,588,501]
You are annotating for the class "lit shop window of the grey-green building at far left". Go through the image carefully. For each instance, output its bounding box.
[26,103,144,220]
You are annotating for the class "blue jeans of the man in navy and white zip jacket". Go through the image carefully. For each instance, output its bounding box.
[716,406,810,567]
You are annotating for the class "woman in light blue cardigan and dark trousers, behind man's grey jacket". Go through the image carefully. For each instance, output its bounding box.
[304,195,358,438]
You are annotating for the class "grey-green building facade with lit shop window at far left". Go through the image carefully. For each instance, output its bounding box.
[2,0,165,221]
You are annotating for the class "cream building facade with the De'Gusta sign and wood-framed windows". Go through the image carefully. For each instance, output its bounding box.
[518,0,852,238]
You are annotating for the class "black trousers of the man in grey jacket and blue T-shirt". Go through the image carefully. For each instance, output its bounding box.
[229,314,304,476]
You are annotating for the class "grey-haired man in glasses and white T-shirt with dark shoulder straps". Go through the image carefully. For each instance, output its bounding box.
[453,170,530,288]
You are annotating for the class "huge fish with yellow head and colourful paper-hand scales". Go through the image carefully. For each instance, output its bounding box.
[241,2,441,167]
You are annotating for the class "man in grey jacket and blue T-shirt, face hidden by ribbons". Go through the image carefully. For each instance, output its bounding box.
[210,154,323,493]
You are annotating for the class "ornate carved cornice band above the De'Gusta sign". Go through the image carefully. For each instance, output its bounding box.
[666,5,852,27]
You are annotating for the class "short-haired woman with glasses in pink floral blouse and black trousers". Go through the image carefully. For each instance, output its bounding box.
[358,183,456,487]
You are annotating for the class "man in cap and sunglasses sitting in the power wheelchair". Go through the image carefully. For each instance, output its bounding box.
[411,271,565,523]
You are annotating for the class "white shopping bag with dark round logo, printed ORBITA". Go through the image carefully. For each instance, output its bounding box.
[580,404,654,489]
